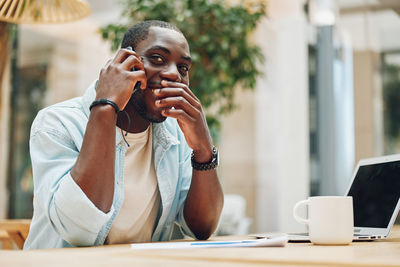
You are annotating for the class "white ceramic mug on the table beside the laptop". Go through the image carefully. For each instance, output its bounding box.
[293,196,354,245]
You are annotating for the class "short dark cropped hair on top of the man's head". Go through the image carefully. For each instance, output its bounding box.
[121,20,183,50]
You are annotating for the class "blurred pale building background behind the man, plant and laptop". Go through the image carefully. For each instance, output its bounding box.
[0,0,400,234]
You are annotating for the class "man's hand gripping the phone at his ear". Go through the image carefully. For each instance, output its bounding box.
[96,49,147,110]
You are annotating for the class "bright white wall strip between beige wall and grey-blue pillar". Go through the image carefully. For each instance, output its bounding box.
[255,0,309,234]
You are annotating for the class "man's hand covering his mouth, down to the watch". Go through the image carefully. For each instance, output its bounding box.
[154,80,213,163]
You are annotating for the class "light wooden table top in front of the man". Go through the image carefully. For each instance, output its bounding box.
[0,227,400,267]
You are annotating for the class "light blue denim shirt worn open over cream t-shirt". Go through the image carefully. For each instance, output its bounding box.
[24,83,194,249]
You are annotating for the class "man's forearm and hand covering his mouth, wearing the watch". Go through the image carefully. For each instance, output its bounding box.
[154,80,223,239]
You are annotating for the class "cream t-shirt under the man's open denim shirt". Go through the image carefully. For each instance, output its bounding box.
[106,125,160,244]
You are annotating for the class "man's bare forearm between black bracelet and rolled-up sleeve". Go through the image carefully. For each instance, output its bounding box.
[71,105,117,212]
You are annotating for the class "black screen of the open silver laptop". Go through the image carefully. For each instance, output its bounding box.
[348,161,400,228]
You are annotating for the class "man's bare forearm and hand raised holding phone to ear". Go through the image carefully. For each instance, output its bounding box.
[71,49,147,212]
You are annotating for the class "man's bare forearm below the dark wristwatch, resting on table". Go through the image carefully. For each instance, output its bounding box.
[184,170,224,239]
